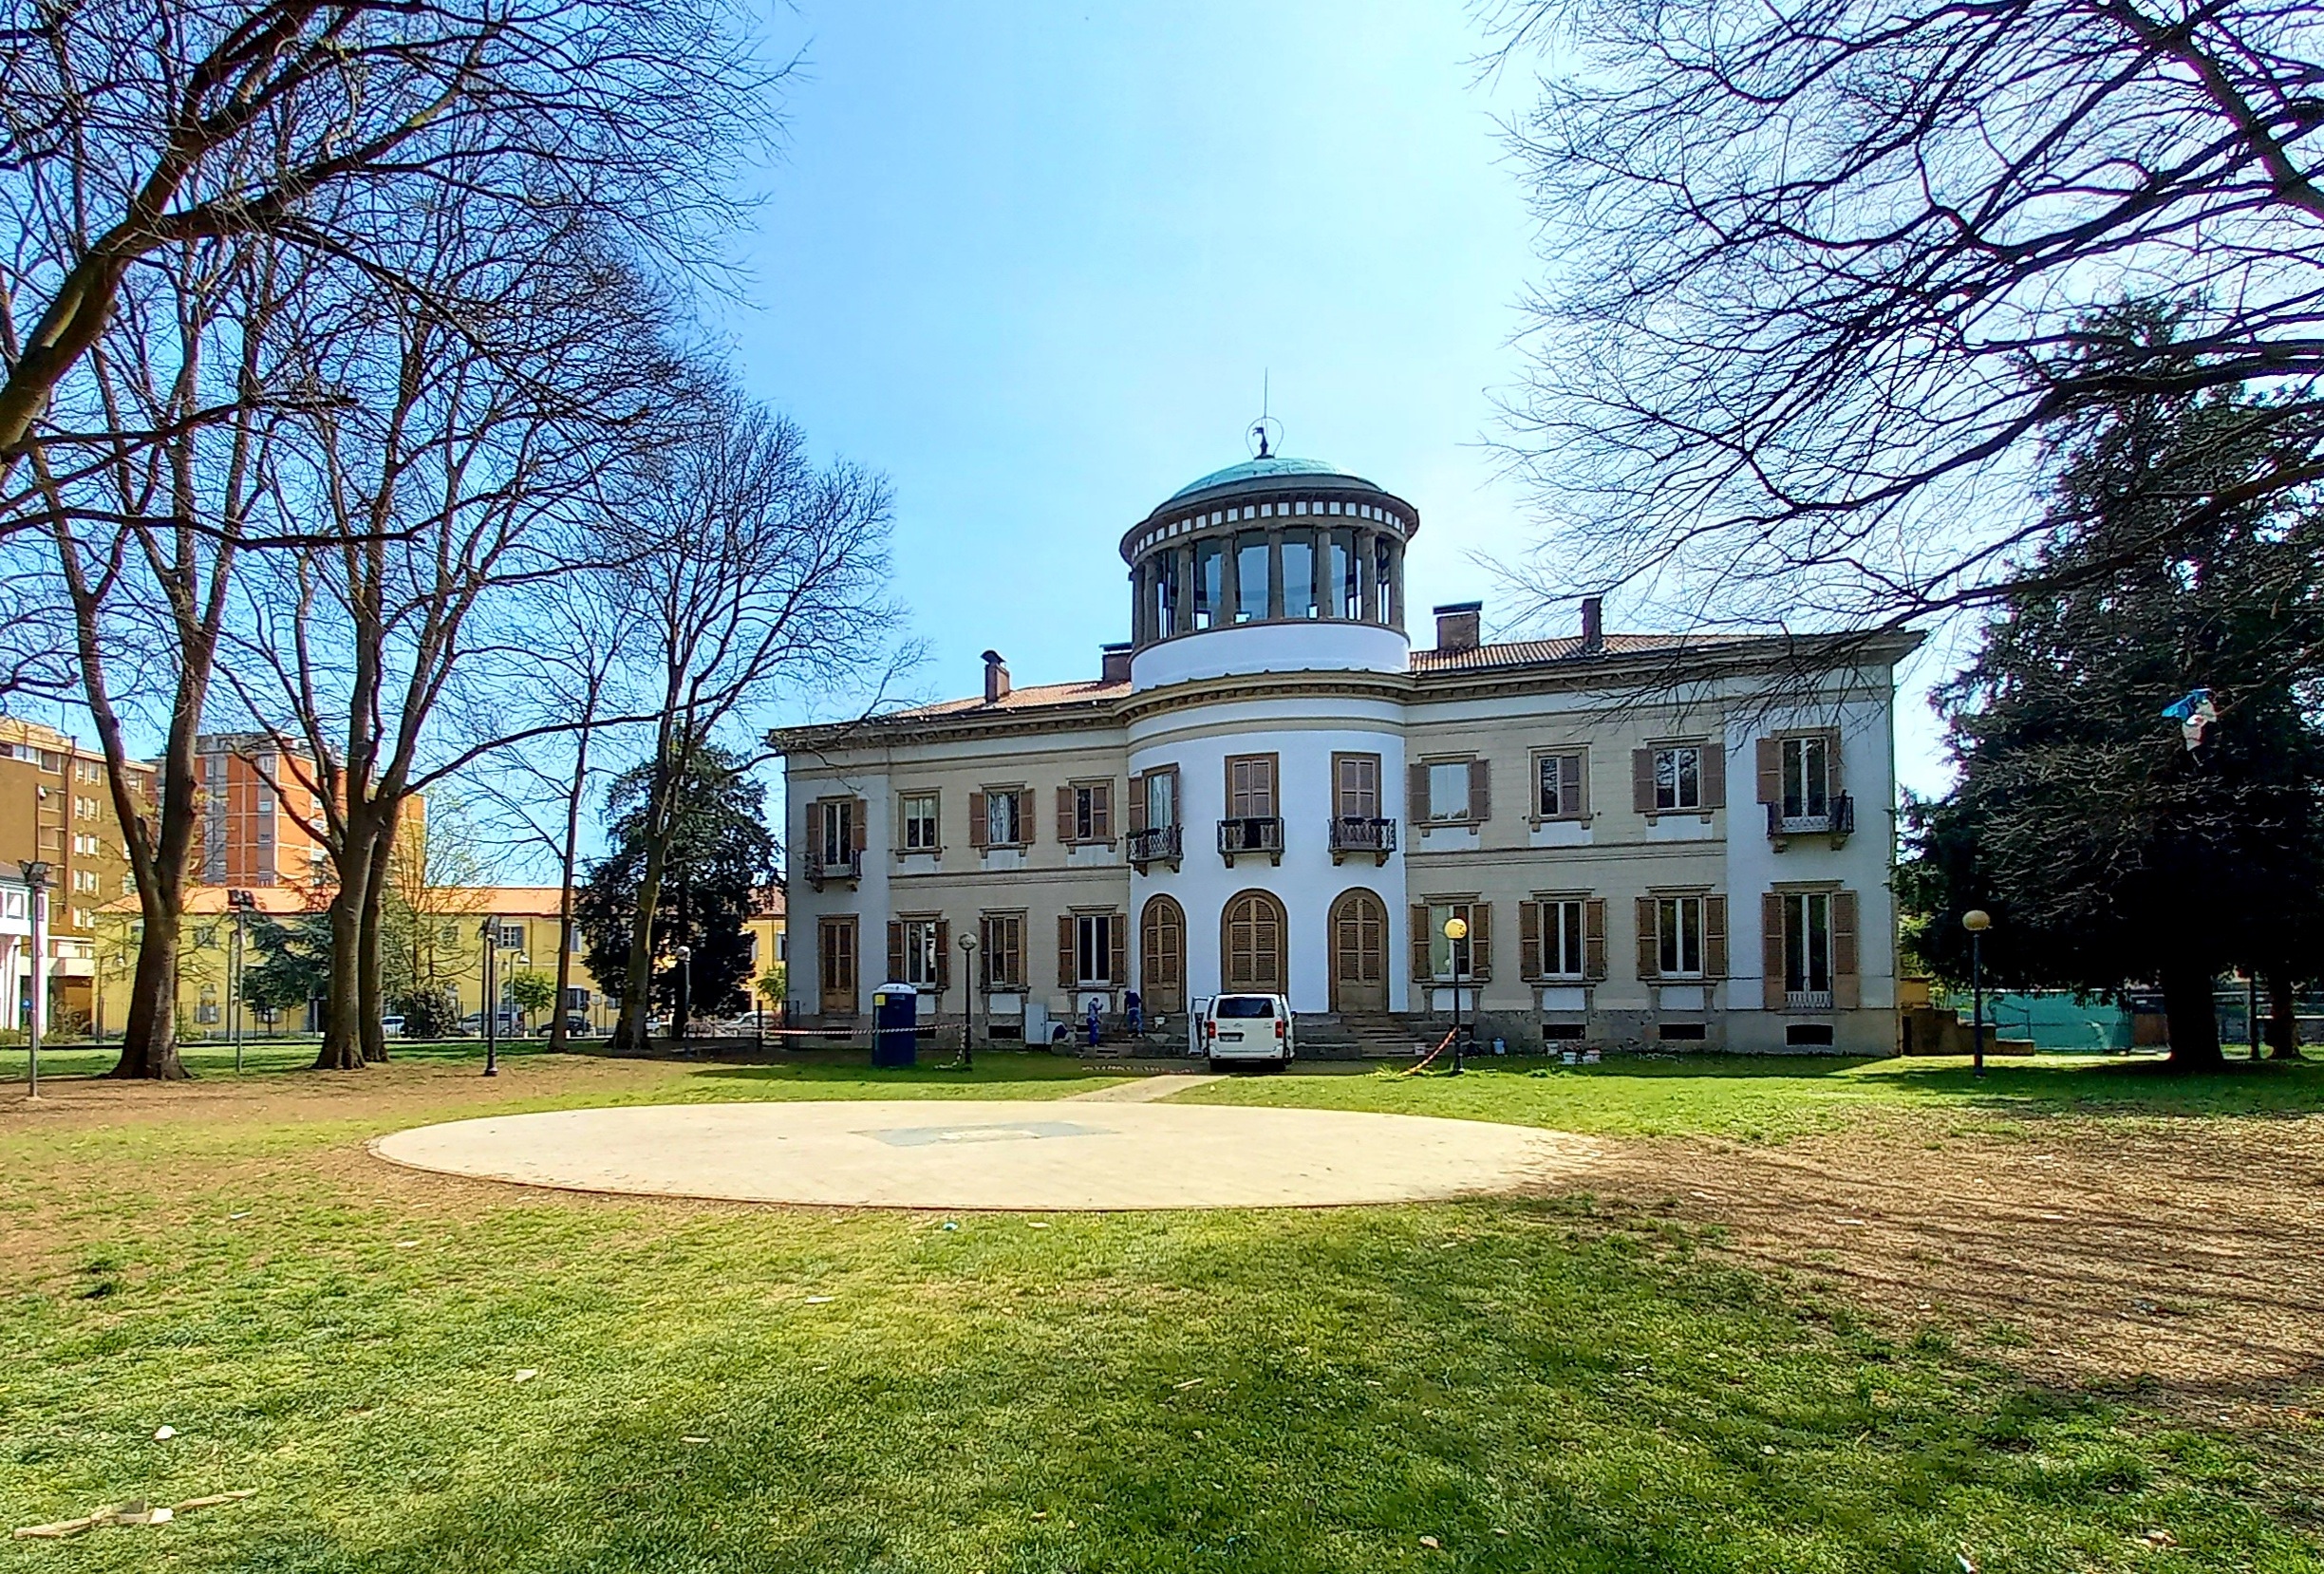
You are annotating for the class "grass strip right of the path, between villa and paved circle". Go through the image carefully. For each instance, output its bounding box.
[1181,1056,2324,1141]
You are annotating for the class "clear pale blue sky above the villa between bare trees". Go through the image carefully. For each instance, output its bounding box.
[725,0,1940,786]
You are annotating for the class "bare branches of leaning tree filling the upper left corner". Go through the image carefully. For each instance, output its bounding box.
[0,0,781,490]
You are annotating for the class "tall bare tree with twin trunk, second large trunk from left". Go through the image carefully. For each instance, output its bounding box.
[234,187,679,1070]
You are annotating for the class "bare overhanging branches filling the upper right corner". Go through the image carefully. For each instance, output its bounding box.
[1490,0,2324,623]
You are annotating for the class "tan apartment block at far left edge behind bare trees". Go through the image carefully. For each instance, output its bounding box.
[0,716,154,1032]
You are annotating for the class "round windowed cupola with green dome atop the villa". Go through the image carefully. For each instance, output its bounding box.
[1122,437,1420,688]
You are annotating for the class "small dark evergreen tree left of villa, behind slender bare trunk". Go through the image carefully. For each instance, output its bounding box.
[574,749,774,1021]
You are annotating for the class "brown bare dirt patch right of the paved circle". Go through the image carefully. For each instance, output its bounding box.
[1592,1116,2324,1420]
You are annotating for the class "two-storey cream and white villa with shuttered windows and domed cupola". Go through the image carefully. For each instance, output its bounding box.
[772,456,1918,1053]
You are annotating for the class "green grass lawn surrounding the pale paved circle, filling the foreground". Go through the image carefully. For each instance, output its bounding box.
[0,1056,2324,1574]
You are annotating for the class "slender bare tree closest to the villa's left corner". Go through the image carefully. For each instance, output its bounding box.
[611,398,888,1049]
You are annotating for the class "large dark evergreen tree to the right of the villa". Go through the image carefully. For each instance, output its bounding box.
[1899,316,2324,1067]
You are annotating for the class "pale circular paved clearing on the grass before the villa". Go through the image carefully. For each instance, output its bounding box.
[372,1099,1592,1211]
